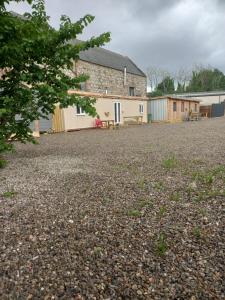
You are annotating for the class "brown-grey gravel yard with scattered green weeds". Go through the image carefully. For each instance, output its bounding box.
[0,118,225,300]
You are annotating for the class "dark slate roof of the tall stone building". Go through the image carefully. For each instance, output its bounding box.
[72,40,146,77]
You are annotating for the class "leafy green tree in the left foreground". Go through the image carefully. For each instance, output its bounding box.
[0,0,110,152]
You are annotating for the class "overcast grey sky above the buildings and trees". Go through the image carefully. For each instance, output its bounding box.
[7,0,225,72]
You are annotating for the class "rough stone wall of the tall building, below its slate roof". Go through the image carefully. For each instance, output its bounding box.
[74,60,147,97]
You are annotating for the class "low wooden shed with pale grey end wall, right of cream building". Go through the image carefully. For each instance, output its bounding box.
[148,96,200,122]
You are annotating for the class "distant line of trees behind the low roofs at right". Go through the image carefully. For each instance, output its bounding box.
[147,65,225,97]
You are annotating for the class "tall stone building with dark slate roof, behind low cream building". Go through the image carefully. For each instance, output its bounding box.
[73,48,147,97]
